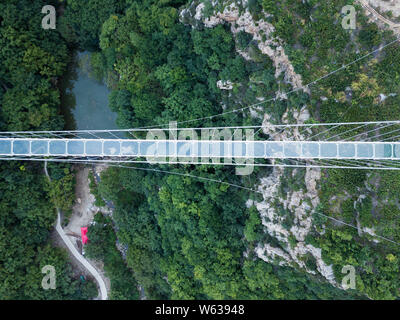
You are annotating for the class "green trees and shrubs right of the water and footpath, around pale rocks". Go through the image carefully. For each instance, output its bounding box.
[90,0,398,299]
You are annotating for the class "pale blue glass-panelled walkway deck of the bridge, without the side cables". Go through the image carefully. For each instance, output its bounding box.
[0,138,400,159]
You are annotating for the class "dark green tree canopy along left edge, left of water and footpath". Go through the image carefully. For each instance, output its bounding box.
[0,0,97,299]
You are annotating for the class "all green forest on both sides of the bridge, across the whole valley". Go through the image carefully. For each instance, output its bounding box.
[0,0,400,300]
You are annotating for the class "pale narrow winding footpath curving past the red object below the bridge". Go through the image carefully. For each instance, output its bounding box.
[44,161,108,300]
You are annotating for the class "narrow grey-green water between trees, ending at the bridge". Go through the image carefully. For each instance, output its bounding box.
[60,52,118,130]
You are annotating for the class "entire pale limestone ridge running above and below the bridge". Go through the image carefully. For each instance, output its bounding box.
[181,1,339,286]
